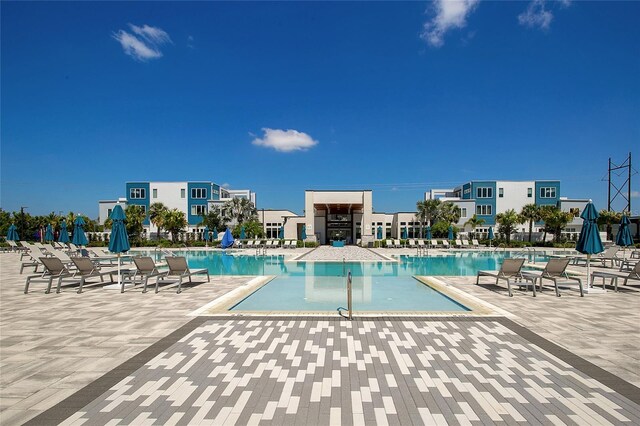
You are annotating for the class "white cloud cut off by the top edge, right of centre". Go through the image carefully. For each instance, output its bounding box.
[420,0,480,47]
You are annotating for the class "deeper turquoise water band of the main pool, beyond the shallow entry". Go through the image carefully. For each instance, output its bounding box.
[142,250,548,277]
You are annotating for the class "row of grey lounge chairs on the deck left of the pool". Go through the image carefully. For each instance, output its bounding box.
[24,256,211,294]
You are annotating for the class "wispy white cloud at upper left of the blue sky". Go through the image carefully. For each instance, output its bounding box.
[113,24,171,62]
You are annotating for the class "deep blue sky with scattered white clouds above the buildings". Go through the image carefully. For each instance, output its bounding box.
[0,0,640,217]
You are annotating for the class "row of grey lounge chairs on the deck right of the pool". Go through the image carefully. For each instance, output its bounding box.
[476,258,640,297]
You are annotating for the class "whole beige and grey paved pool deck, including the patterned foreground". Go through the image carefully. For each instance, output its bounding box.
[0,249,640,425]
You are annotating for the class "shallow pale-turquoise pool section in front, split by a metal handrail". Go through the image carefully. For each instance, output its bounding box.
[230,276,469,312]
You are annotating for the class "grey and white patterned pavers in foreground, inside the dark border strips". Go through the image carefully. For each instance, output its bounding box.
[63,318,640,425]
